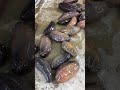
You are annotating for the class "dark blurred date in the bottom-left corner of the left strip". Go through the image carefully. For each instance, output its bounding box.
[0,74,23,90]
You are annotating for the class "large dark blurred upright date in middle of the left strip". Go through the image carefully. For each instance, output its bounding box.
[11,22,35,75]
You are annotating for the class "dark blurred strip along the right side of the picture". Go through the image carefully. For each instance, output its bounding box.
[86,0,120,90]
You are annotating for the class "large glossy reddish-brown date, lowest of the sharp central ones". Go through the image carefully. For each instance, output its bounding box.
[55,62,79,83]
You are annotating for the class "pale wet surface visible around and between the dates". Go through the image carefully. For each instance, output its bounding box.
[35,0,85,90]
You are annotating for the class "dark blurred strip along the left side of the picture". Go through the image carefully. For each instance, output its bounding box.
[0,0,35,90]
